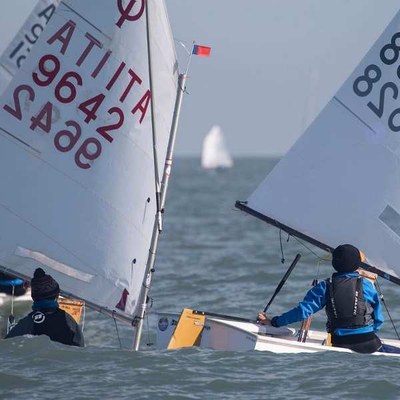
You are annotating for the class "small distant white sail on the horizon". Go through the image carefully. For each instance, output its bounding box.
[201,125,233,169]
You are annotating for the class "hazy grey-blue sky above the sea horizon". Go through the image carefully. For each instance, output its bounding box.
[0,0,400,157]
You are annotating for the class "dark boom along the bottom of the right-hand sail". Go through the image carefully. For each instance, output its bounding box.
[235,201,400,285]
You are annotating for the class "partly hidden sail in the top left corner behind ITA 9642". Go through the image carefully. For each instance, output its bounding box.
[0,0,61,94]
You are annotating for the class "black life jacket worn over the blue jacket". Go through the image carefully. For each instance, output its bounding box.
[325,275,373,333]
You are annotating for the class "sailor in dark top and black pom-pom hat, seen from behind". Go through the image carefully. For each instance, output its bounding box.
[6,268,84,347]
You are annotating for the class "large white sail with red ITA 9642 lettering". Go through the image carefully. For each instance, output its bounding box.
[0,0,178,316]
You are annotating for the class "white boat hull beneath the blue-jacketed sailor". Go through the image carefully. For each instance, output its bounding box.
[157,313,400,357]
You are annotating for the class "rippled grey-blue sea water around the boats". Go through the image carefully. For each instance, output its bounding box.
[0,158,400,400]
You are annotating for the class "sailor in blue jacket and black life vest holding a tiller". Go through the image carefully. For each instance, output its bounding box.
[258,244,384,353]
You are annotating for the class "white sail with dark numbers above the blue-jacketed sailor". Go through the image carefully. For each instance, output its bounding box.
[247,9,400,273]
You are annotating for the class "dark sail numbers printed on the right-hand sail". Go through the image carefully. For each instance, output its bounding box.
[353,32,400,132]
